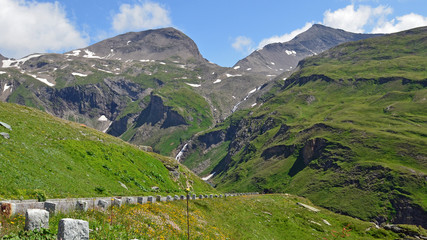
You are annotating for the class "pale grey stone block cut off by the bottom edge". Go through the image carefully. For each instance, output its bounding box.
[58,218,89,240]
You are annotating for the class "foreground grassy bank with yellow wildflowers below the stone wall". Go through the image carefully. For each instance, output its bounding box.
[0,195,427,239]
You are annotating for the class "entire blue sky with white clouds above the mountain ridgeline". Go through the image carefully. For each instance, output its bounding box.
[0,0,427,66]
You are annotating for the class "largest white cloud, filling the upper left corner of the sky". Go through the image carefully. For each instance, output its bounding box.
[0,0,89,58]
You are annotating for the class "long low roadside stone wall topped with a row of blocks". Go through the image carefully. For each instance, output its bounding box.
[0,193,259,216]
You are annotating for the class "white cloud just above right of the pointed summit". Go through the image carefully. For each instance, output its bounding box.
[323,4,393,33]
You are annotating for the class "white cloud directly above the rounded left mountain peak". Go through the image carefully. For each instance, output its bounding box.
[112,2,171,32]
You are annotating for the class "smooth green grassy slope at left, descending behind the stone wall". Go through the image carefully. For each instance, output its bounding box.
[0,103,212,199]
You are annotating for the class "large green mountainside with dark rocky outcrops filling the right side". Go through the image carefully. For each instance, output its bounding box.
[189,28,427,227]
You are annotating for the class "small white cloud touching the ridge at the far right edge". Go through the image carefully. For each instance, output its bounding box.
[372,13,427,33]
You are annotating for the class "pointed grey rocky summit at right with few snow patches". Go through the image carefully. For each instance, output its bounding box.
[234,24,380,76]
